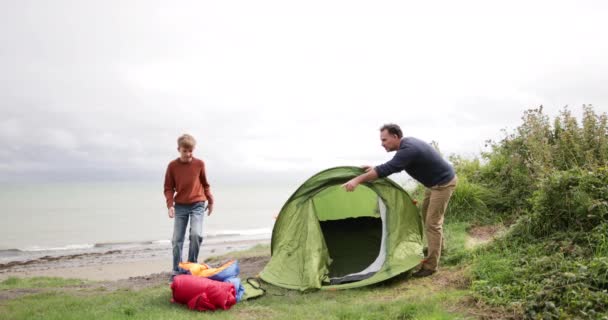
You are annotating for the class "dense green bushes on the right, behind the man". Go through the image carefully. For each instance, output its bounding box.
[470,106,608,319]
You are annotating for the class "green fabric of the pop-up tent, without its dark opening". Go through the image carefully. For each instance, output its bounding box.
[260,167,422,290]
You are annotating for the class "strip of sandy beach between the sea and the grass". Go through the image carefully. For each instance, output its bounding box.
[0,239,270,281]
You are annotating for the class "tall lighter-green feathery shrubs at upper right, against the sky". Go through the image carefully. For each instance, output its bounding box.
[471,105,608,216]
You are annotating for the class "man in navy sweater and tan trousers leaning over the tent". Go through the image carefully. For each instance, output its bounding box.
[342,124,458,277]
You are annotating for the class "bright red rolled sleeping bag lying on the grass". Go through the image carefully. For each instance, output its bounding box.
[171,274,236,311]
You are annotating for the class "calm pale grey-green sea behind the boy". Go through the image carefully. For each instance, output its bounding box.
[0,182,296,262]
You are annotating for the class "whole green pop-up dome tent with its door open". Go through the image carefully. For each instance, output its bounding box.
[260,167,422,290]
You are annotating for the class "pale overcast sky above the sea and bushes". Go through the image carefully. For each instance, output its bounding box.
[0,0,608,183]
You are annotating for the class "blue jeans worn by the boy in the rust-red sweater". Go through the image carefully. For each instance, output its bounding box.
[171,202,207,274]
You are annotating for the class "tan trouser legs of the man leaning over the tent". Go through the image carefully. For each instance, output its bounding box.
[422,178,457,271]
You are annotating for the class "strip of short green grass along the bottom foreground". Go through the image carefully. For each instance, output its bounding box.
[0,279,466,319]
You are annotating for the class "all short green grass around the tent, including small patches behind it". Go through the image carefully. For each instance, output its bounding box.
[0,223,478,320]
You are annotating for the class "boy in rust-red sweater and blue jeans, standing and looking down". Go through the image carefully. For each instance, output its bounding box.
[165,134,213,280]
